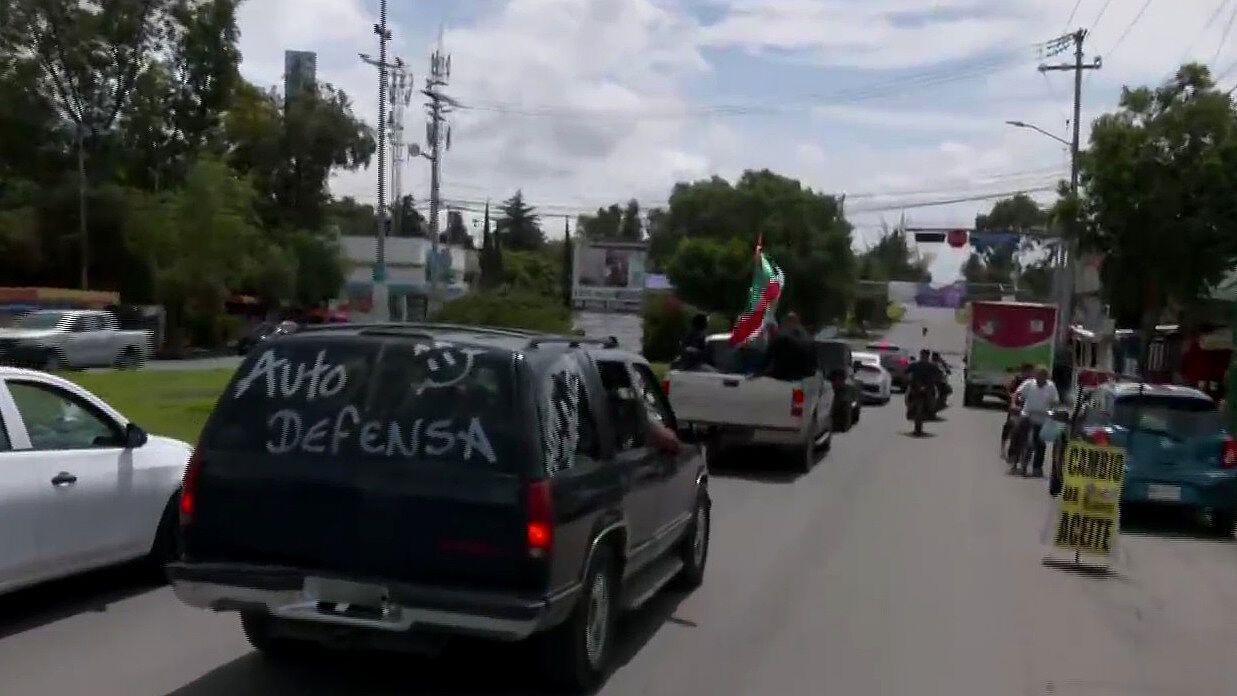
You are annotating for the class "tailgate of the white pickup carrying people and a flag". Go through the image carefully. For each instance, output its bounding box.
[669,371,803,428]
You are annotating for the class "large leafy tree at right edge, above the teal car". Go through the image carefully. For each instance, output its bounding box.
[1080,63,1237,358]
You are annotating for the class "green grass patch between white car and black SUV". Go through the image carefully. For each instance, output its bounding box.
[61,368,234,445]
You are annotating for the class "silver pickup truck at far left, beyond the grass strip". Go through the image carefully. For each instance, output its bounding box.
[0,309,150,371]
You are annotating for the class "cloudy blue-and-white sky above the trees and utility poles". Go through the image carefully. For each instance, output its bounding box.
[240,0,1237,281]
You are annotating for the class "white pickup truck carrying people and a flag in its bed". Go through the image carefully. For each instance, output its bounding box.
[663,334,834,471]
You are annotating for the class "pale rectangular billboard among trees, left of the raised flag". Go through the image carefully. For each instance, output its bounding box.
[571,239,648,313]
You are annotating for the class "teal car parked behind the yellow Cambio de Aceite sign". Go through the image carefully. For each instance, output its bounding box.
[1074,382,1237,535]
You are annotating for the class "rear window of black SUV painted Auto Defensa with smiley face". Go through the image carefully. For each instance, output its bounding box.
[203,336,522,471]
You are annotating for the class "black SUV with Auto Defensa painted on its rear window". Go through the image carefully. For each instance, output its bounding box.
[168,324,710,689]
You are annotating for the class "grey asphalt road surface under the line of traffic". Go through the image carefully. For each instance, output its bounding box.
[0,312,1237,696]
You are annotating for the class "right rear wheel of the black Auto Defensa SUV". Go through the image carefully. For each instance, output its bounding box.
[541,545,620,692]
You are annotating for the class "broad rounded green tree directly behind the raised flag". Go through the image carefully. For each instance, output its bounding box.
[649,169,856,325]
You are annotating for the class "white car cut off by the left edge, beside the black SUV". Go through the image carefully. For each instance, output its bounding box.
[0,367,190,592]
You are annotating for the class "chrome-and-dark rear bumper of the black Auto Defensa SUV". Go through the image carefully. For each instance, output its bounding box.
[167,562,580,640]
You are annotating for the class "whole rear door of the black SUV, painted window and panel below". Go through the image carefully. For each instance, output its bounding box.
[182,334,542,588]
